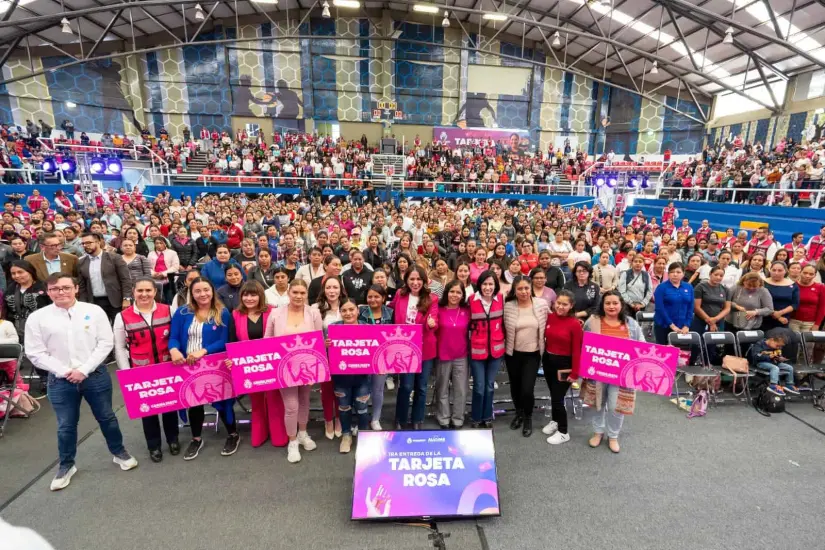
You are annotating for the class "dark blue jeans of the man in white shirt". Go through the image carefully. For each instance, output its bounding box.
[49,366,126,468]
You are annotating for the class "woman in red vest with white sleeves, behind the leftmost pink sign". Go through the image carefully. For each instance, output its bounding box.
[113,277,180,462]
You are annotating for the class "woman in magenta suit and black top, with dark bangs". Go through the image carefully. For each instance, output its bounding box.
[227,281,288,447]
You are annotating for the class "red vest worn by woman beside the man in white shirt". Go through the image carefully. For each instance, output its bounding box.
[121,304,172,368]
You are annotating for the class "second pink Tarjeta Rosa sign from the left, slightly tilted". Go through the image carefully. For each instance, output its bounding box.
[226,330,330,394]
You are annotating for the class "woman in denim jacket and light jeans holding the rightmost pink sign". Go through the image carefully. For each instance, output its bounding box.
[582,290,645,453]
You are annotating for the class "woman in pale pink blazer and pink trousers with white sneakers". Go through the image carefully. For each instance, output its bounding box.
[264,279,323,463]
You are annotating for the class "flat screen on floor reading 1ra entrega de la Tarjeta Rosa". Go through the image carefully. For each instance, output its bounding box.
[352,430,501,520]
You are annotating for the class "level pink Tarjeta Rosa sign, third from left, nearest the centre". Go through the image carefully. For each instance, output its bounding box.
[328,325,424,374]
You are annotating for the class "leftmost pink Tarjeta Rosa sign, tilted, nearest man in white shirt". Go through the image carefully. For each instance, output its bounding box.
[117,353,235,419]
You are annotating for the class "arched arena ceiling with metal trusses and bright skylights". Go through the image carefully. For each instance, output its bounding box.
[0,0,825,110]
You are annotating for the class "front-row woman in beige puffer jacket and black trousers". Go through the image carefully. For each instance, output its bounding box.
[504,276,555,437]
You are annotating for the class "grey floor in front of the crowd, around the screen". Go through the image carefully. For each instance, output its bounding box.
[0,366,825,550]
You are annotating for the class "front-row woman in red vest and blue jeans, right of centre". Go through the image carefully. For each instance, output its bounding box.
[468,271,504,428]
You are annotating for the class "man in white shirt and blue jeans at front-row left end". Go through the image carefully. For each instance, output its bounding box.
[25,273,137,491]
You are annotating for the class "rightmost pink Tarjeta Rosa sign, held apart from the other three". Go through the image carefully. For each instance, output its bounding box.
[579,332,679,395]
